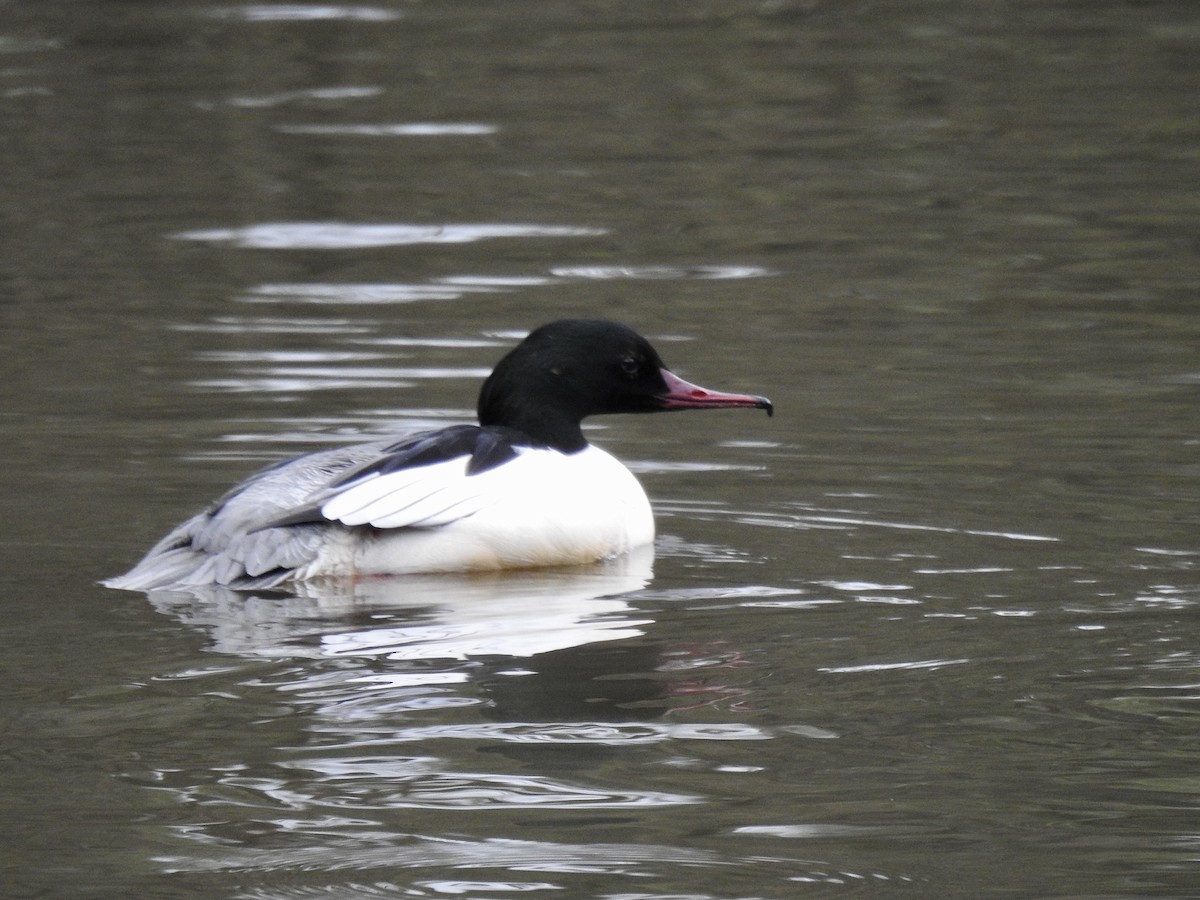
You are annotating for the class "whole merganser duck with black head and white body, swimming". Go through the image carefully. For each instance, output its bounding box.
[104,319,773,590]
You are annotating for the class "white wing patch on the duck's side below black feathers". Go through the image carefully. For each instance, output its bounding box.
[320,448,540,528]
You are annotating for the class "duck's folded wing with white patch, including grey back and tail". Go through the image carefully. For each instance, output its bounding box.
[106,425,540,590]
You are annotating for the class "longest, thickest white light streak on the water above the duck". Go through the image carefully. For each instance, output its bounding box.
[172,222,607,250]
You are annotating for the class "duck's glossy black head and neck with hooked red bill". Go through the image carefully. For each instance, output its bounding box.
[479,319,772,452]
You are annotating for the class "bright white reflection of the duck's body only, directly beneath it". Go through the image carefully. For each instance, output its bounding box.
[150,547,654,660]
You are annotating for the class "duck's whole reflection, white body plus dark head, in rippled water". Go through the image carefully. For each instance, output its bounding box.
[149,547,745,724]
